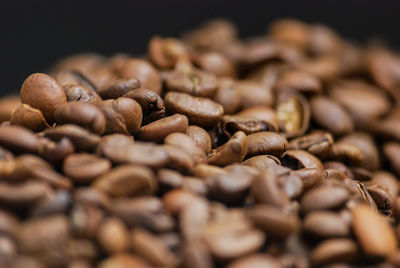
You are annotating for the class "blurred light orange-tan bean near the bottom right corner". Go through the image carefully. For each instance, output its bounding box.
[352,205,397,257]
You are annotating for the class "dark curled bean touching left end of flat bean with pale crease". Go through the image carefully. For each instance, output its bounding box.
[123,88,165,123]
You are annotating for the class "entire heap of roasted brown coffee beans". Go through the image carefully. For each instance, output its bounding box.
[0,19,400,268]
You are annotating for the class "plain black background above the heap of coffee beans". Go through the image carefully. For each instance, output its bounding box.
[0,0,400,95]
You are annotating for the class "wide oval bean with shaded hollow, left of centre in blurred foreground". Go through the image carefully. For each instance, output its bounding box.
[93,165,157,197]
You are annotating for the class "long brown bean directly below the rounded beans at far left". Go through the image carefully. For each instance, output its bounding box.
[44,124,101,150]
